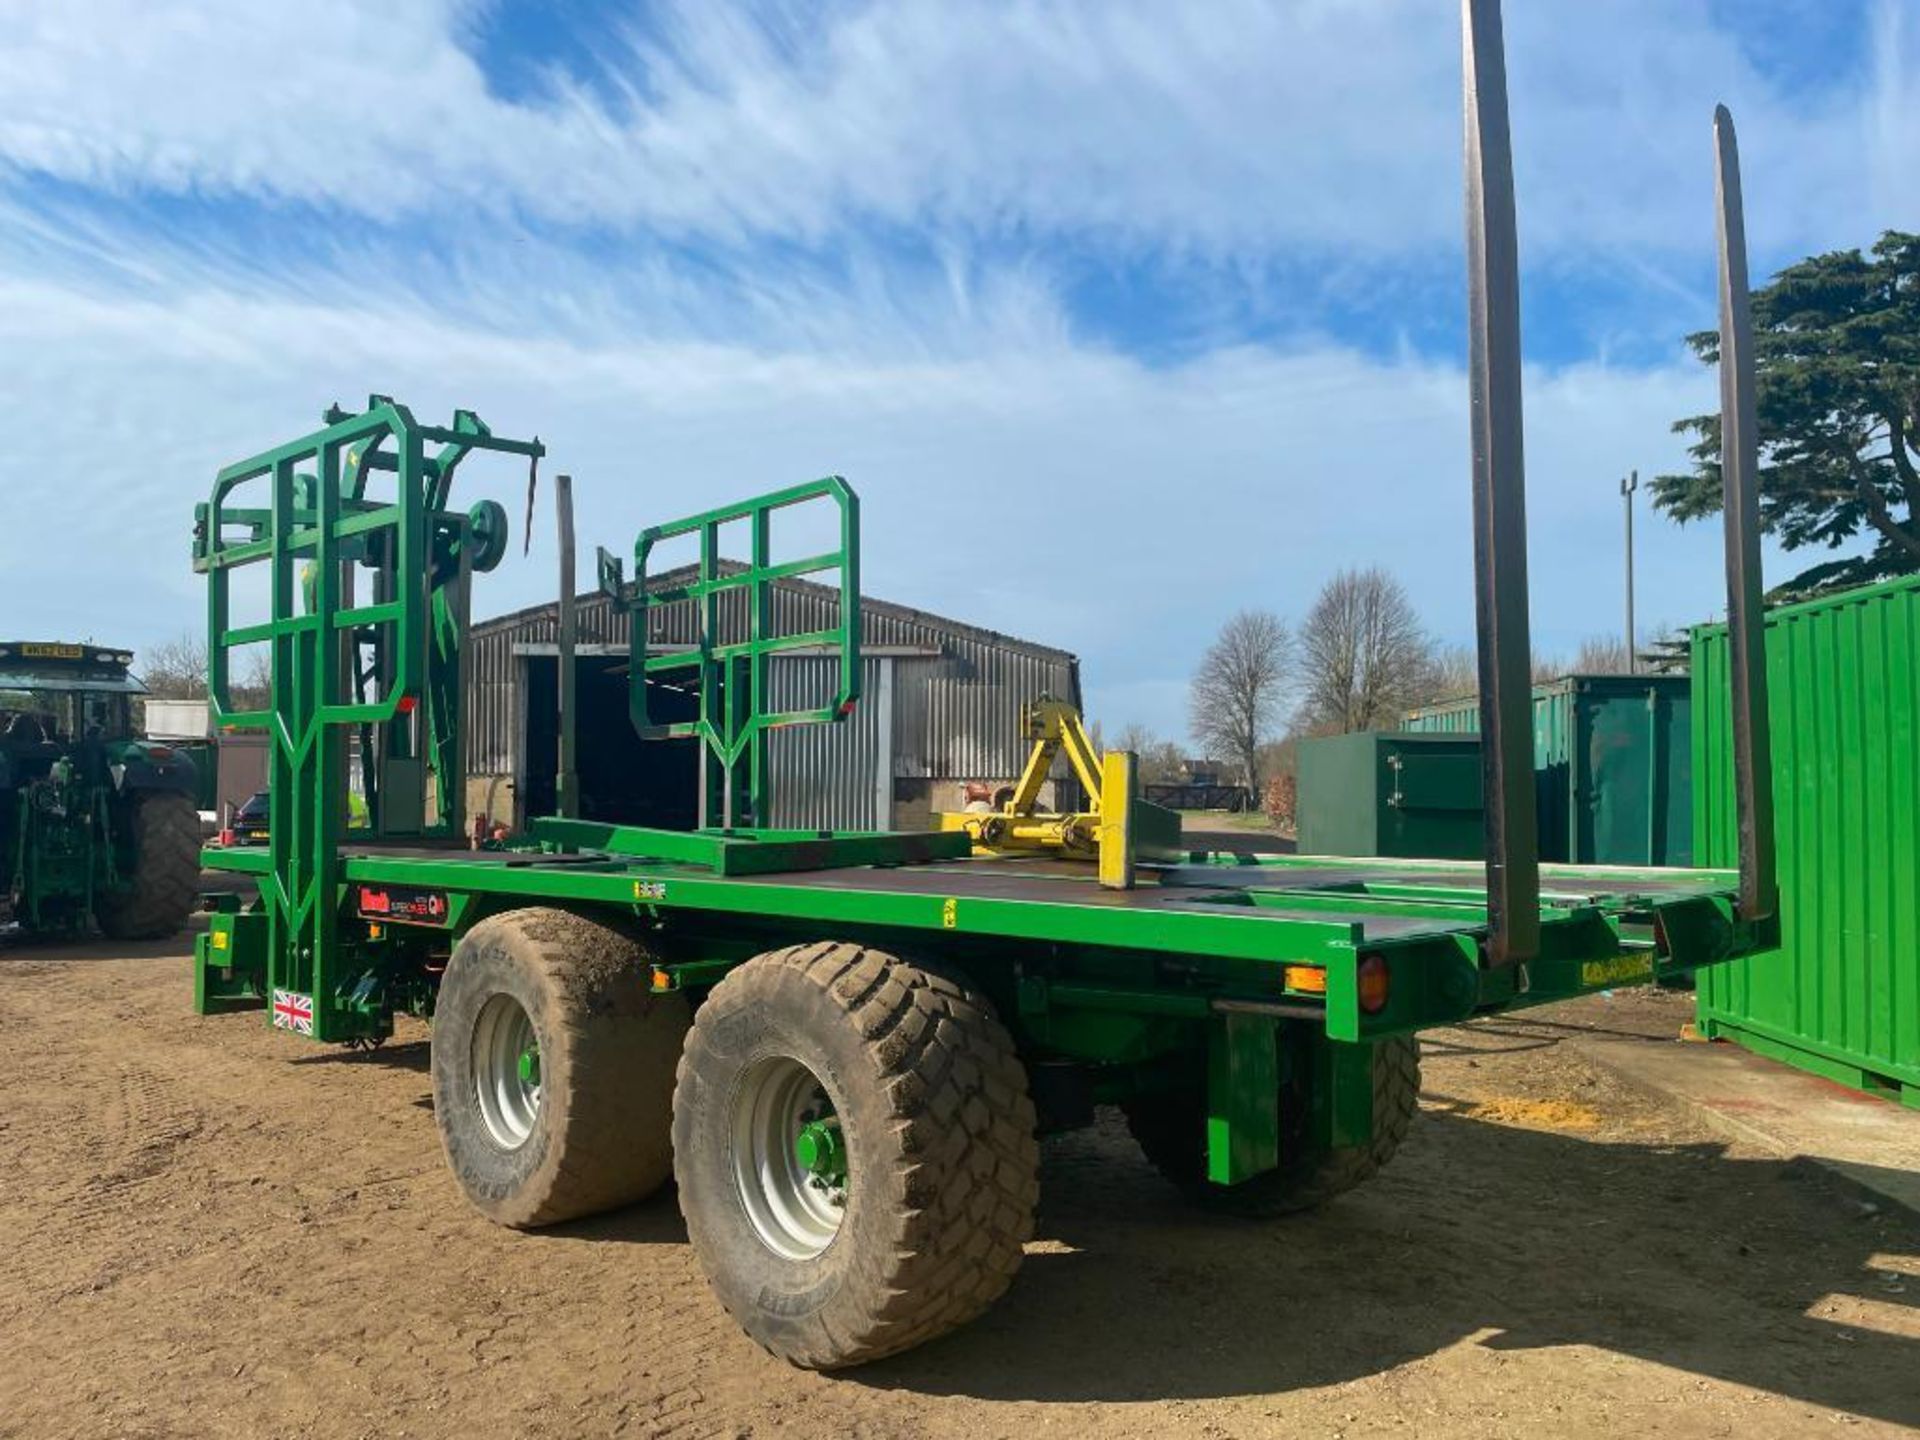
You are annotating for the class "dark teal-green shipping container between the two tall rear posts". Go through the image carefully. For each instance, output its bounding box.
[1405,676,1693,866]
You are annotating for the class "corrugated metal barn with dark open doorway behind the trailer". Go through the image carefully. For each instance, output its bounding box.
[456,572,1081,829]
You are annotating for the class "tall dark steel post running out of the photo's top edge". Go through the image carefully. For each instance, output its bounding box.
[1461,0,1540,966]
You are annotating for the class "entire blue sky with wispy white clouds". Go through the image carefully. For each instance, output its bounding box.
[0,0,1920,733]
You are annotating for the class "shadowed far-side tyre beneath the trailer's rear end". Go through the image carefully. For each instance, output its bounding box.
[1125,1035,1421,1219]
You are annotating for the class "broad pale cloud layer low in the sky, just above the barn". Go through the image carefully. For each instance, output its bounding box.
[0,259,1751,730]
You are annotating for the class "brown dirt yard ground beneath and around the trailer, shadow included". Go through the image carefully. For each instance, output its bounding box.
[0,929,1920,1440]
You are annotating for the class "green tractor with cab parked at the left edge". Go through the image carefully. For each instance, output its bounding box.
[0,641,200,941]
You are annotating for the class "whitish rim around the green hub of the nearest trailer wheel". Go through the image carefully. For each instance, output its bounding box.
[733,1056,847,1260]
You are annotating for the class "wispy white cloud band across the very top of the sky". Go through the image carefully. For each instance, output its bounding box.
[0,0,1920,255]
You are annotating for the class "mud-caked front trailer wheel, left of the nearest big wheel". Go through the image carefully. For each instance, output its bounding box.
[434,906,687,1229]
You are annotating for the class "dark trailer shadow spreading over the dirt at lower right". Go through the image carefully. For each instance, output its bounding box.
[849,1110,1920,1425]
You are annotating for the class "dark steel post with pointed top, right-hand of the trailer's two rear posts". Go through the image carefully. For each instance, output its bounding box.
[1713,106,1780,920]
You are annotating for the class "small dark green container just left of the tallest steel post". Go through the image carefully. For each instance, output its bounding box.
[1294,732,1486,860]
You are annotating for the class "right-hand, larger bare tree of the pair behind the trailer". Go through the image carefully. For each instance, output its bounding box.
[1300,566,1434,733]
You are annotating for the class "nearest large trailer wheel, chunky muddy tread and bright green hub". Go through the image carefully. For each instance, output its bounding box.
[674,943,1039,1369]
